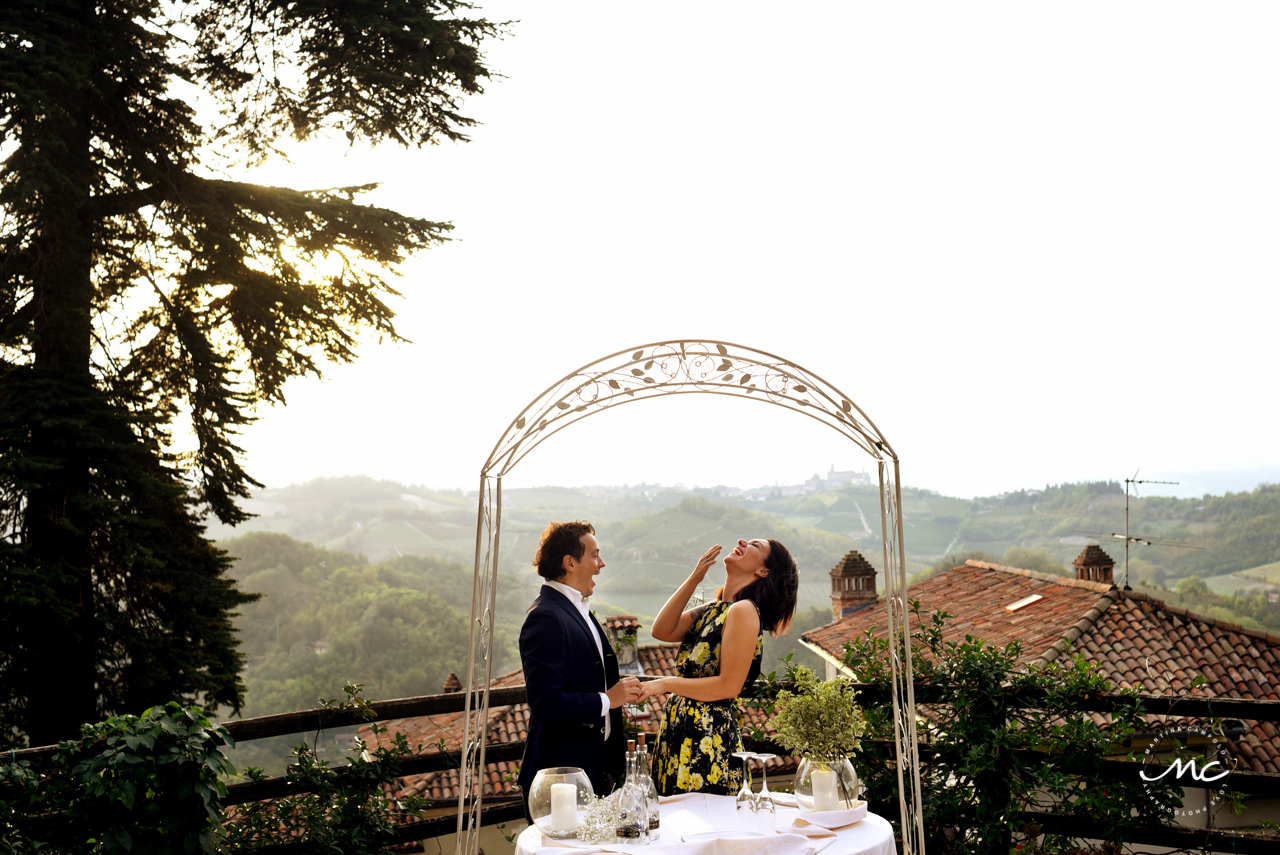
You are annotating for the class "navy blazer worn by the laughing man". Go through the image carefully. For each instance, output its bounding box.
[518,585,626,810]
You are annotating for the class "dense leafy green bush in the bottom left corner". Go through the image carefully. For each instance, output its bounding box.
[0,703,234,855]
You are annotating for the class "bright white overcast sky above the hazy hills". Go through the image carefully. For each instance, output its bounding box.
[230,0,1280,497]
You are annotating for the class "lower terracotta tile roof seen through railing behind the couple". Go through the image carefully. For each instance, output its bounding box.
[360,616,796,800]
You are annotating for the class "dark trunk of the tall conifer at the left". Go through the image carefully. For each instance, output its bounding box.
[23,4,100,745]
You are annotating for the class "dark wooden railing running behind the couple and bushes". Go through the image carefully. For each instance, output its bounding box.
[15,685,1280,855]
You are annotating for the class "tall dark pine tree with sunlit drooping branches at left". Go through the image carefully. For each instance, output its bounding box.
[0,0,502,744]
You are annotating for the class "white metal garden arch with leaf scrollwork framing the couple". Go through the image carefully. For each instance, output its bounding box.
[457,339,924,855]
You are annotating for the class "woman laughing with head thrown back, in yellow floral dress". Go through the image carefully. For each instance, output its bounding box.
[644,539,799,796]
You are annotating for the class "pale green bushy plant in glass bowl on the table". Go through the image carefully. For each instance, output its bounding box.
[769,667,867,756]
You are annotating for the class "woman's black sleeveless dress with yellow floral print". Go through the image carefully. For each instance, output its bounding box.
[653,602,764,796]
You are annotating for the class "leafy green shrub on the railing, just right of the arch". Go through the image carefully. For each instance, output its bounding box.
[845,602,1183,855]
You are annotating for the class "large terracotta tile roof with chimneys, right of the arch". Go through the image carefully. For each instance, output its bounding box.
[803,561,1280,772]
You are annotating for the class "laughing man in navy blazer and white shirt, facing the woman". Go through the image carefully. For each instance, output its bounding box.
[520,521,640,820]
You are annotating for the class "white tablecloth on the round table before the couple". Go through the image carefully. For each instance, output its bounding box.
[516,794,897,855]
